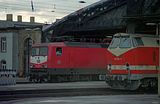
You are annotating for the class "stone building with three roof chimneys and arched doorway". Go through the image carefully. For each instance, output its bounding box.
[0,14,43,77]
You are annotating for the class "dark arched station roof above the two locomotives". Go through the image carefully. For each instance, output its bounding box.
[43,0,160,41]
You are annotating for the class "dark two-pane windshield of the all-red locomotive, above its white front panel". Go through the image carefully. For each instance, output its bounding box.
[31,47,48,56]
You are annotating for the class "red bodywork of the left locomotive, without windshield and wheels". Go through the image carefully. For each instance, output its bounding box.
[30,42,108,80]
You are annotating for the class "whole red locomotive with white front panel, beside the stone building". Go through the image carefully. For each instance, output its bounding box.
[30,42,108,82]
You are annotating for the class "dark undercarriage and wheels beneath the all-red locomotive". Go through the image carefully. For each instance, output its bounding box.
[30,68,106,82]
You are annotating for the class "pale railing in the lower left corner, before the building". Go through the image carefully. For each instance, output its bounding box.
[0,69,16,86]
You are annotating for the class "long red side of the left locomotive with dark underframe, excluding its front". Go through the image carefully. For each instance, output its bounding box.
[29,43,107,82]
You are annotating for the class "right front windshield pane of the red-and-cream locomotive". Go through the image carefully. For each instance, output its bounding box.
[119,37,131,48]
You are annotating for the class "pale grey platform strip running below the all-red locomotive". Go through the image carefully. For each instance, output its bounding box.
[0,81,107,91]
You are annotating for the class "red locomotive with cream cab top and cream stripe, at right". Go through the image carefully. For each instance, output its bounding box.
[106,33,160,90]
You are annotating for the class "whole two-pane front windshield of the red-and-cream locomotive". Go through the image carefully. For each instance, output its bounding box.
[109,36,131,48]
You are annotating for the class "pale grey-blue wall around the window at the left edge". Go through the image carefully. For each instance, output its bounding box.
[0,32,14,69]
